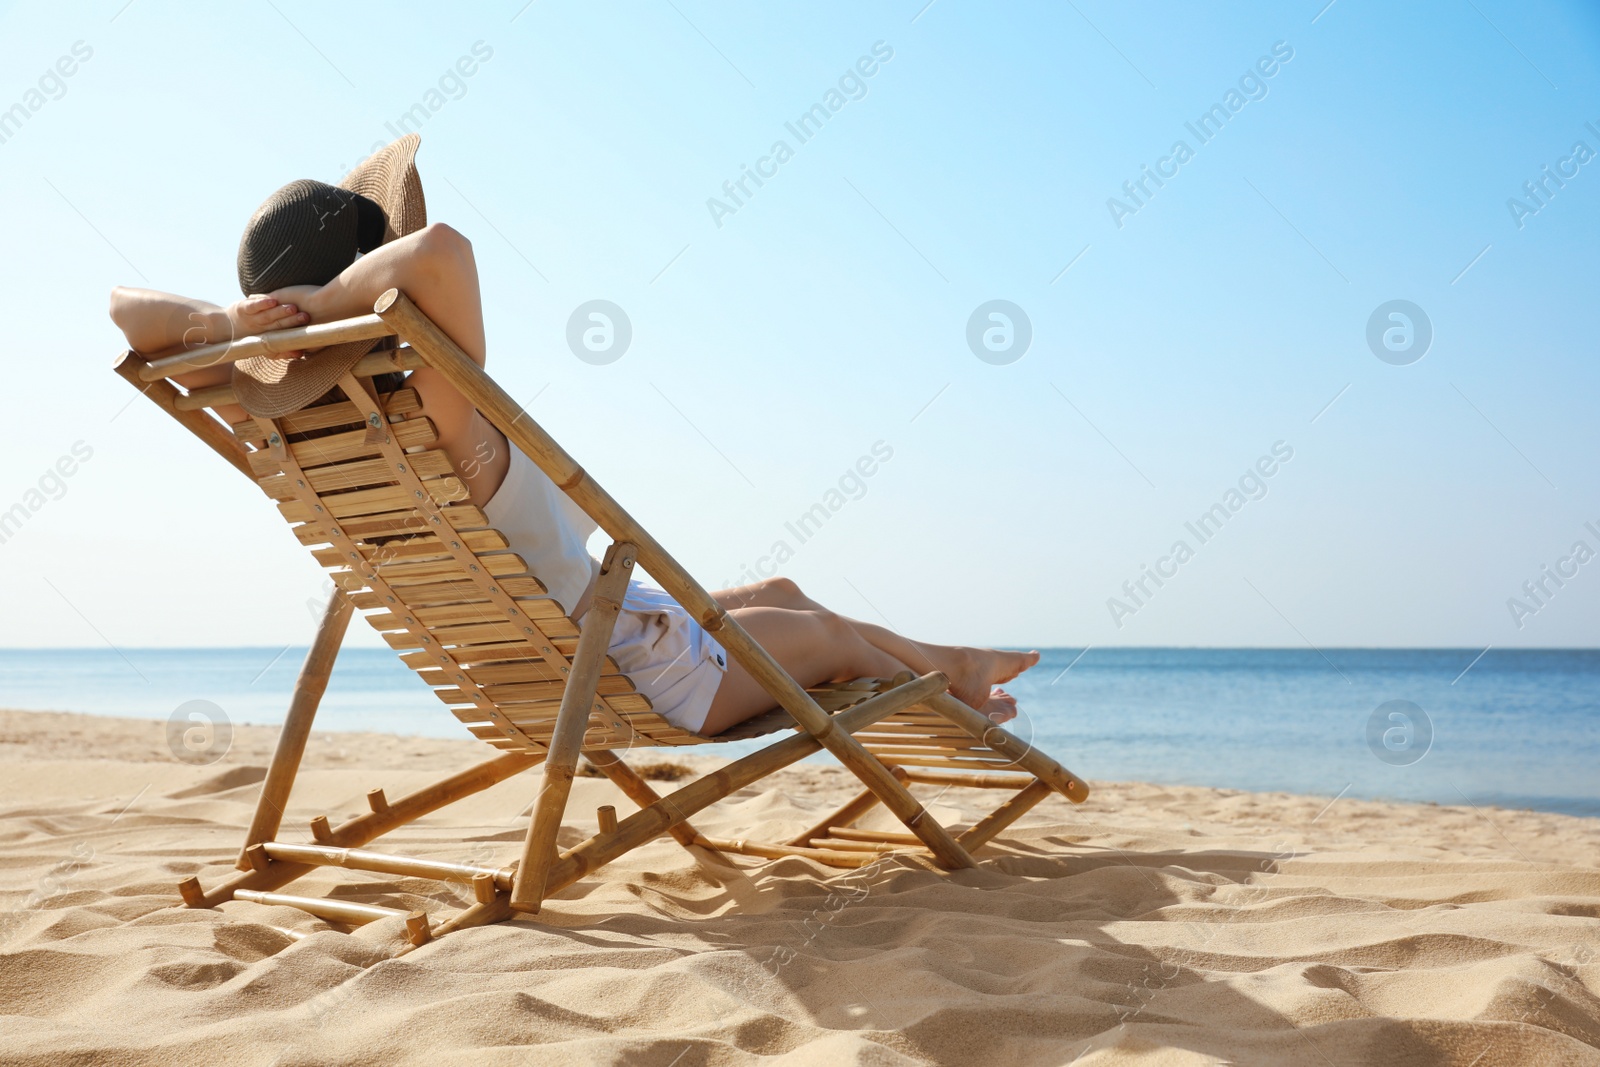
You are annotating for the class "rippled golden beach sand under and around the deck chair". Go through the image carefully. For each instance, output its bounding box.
[0,712,1600,1067]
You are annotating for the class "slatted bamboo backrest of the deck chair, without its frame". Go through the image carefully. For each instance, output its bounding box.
[234,376,702,753]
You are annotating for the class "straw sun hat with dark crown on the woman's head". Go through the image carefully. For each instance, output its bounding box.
[234,133,427,418]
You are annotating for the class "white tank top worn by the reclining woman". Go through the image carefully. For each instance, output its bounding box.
[483,445,600,614]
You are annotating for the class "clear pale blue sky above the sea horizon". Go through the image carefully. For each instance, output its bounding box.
[0,0,1600,648]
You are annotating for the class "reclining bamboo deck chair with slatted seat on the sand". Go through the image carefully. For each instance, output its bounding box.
[117,290,1088,944]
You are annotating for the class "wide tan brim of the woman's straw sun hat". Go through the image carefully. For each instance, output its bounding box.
[234,133,427,419]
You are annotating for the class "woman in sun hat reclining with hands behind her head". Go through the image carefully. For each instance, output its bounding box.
[110,134,1038,736]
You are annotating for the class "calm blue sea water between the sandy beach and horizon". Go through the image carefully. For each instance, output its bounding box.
[0,648,1600,832]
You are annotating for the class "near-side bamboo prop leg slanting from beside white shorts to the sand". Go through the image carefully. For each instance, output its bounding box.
[510,542,638,912]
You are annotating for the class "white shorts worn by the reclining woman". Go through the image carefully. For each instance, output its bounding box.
[598,579,728,734]
